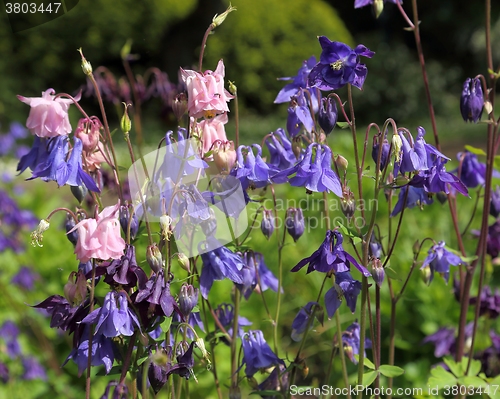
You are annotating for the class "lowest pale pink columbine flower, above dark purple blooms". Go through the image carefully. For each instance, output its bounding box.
[68,203,125,263]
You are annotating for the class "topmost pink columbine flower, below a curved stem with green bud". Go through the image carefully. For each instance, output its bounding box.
[181,60,234,118]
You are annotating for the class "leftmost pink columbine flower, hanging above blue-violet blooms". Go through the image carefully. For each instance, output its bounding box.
[17,89,80,137]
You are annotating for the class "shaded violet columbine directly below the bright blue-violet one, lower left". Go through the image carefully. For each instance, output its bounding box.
[63,326,115,376]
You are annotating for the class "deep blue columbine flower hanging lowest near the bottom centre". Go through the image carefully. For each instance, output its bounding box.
[241,330,284,378]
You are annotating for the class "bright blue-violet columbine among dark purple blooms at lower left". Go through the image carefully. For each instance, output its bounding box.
[82,291,141,338]
